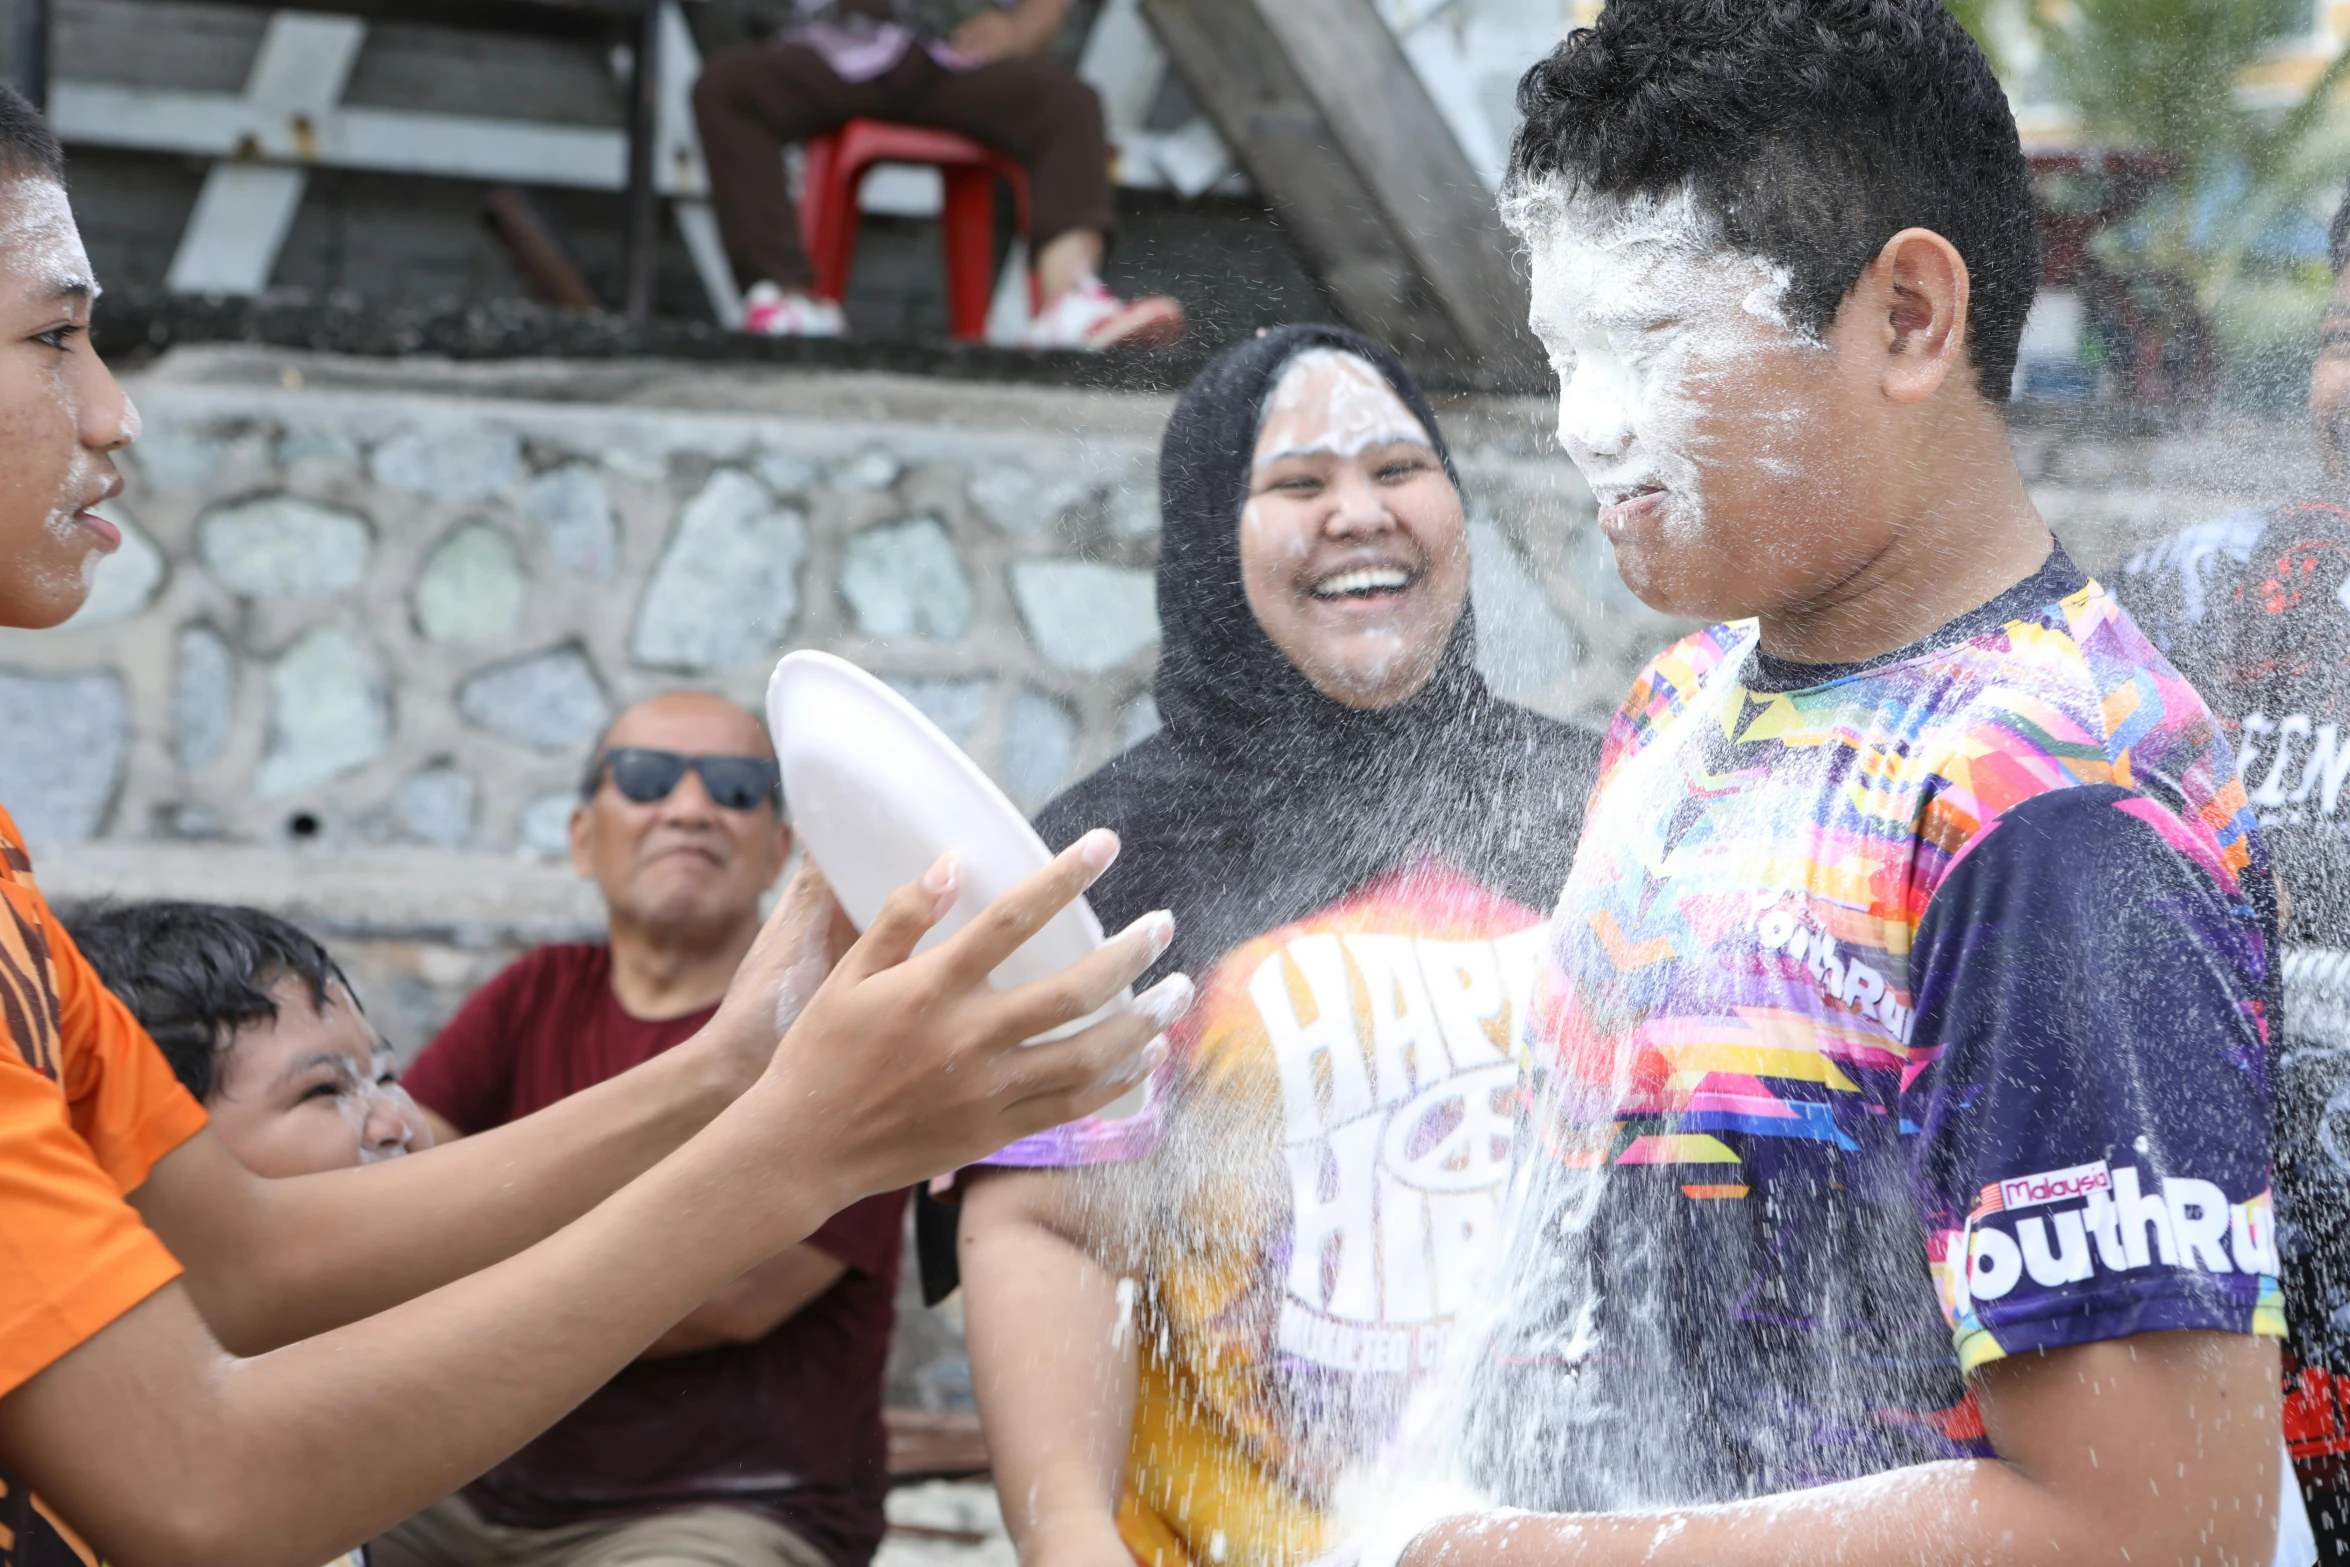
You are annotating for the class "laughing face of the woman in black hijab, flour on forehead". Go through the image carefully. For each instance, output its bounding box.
[1241,348,1469,709]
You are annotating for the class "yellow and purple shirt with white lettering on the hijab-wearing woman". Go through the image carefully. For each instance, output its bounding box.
[989,860,1542,1567]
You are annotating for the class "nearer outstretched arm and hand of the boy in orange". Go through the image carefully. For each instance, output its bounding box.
[0,834,1187,1567]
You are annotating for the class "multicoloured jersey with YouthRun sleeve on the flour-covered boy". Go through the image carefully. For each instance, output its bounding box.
[1488,550,2282,1506]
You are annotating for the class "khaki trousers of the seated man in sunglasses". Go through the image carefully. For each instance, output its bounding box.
[367,1494,832,1567]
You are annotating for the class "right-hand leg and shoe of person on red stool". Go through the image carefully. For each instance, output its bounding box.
[907,59,1182,348]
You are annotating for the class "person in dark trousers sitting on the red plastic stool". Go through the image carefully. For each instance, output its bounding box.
[693,0,1182,350]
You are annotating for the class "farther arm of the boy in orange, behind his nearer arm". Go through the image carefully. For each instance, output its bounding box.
[132,865,853,1353]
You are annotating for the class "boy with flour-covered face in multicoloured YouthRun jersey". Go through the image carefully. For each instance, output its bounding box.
[1368,0,2308,1567]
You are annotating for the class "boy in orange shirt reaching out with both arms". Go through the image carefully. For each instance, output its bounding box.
[0,89,1182,1567]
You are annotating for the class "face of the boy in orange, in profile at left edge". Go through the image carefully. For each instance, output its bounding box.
[0,174,139,630]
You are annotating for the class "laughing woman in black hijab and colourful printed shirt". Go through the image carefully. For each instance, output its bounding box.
[961,327,1598,1567]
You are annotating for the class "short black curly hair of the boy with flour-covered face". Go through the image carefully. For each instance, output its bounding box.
[1506,0,2040,402]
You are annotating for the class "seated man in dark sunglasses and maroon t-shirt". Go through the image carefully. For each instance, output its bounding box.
[374,691,905,1567]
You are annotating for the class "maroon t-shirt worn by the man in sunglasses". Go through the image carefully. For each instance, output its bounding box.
[402,944,905,1567]
